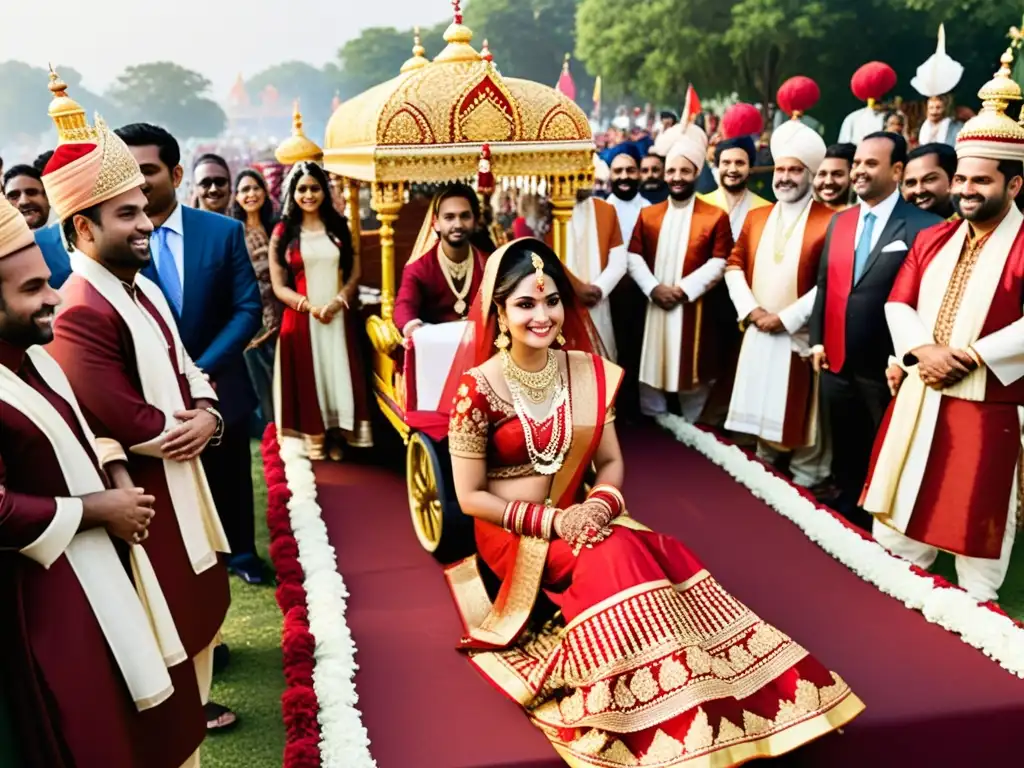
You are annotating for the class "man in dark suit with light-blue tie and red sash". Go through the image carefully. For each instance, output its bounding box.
[810,132,942,529]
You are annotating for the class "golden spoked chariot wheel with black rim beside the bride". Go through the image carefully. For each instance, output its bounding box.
[406,432,475,563]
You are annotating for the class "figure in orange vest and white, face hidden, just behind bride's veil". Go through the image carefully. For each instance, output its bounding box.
[565,196,627,361]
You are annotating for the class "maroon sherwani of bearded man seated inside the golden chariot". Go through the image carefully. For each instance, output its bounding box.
[394,243,486,333]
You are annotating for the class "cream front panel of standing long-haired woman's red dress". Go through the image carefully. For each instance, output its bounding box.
[299,229,355,431]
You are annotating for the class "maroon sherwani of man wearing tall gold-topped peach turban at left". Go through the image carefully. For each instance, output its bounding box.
[50,274,230,658]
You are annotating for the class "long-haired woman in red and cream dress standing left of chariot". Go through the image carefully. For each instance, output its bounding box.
[269,162,373,461]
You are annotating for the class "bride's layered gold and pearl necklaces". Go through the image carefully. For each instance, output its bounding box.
[502,349,572,475]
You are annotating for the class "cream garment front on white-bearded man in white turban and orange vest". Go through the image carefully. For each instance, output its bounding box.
[725,199,813,442]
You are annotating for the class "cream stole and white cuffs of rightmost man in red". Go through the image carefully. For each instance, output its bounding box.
[864,206,1024,531]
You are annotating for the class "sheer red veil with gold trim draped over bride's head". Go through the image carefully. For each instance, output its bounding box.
[439,238,604,412]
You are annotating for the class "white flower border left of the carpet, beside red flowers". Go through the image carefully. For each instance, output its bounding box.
[281,437,377,768]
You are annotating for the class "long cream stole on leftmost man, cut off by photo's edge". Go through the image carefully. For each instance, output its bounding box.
[0,347,185,712]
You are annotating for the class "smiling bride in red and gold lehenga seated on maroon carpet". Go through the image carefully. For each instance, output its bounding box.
[445,239,863,768]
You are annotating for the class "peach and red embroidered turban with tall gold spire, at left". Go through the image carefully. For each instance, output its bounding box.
[43,72,145,221]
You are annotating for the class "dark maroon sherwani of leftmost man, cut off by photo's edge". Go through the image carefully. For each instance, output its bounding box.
[0,341,206,768]
